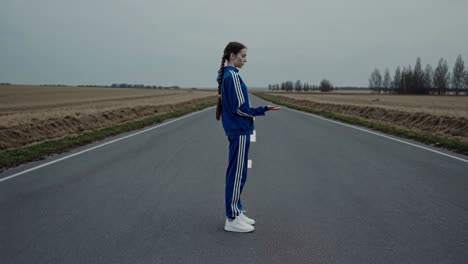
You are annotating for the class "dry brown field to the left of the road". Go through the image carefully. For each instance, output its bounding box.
[0,85,216,149]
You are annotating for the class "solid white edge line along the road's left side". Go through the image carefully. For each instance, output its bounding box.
[0,106,214,182]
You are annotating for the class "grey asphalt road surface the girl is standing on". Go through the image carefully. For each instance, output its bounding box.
[0,95,468,264]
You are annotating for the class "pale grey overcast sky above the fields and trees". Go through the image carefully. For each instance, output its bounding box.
[0,0,468,88]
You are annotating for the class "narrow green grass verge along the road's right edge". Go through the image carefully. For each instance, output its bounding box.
[254,93,468,155]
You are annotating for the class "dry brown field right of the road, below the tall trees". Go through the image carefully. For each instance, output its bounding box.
[258,92,468,142]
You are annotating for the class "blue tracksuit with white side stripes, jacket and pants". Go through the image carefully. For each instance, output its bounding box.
[221,66,268,218]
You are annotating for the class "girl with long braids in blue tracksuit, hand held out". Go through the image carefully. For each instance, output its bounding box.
[216,42,281,232]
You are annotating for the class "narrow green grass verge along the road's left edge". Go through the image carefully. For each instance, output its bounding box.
[0,102,216,171]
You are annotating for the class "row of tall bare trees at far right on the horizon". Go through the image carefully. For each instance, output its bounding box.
[369,55,468,95]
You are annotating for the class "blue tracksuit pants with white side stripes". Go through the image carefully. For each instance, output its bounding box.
[225,135,250,218]
